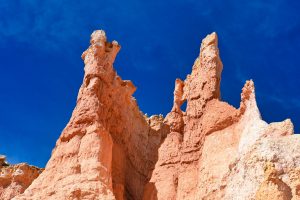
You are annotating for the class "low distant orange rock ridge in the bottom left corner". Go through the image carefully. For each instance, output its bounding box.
[0,155,42,200]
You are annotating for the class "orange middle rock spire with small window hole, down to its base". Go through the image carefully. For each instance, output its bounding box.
[144,33,238,199]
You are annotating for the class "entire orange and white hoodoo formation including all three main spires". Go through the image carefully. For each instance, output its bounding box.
[14,31,300,200]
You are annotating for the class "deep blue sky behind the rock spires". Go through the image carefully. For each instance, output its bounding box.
[0,0,300,167]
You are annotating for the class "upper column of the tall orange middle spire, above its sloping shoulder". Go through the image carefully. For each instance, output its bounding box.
[184,33,223,117]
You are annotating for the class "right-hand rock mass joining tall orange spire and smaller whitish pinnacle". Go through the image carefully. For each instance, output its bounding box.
[144,33,300,200]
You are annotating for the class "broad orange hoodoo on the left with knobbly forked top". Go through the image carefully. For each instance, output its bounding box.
[16,31,169,200]
